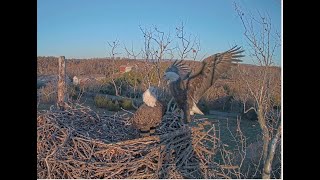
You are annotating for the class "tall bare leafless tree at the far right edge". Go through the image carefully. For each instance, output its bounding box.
[235,4,281,179]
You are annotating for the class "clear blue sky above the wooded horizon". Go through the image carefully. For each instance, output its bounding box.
[37,0,281,65]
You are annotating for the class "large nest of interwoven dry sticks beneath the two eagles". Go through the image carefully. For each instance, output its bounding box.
[37,102,228,179]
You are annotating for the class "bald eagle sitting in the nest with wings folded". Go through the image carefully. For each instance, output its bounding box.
[131,86,165,136]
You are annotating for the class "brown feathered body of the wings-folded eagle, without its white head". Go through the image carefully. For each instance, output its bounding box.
[131,101,165,132]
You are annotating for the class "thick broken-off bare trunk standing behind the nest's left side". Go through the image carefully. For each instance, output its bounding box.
[57,56,66,110]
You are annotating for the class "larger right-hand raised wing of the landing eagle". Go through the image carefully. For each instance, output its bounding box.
[186,46,244,103]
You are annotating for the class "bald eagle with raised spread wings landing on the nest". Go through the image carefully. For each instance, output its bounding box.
[163,46,244,123]
